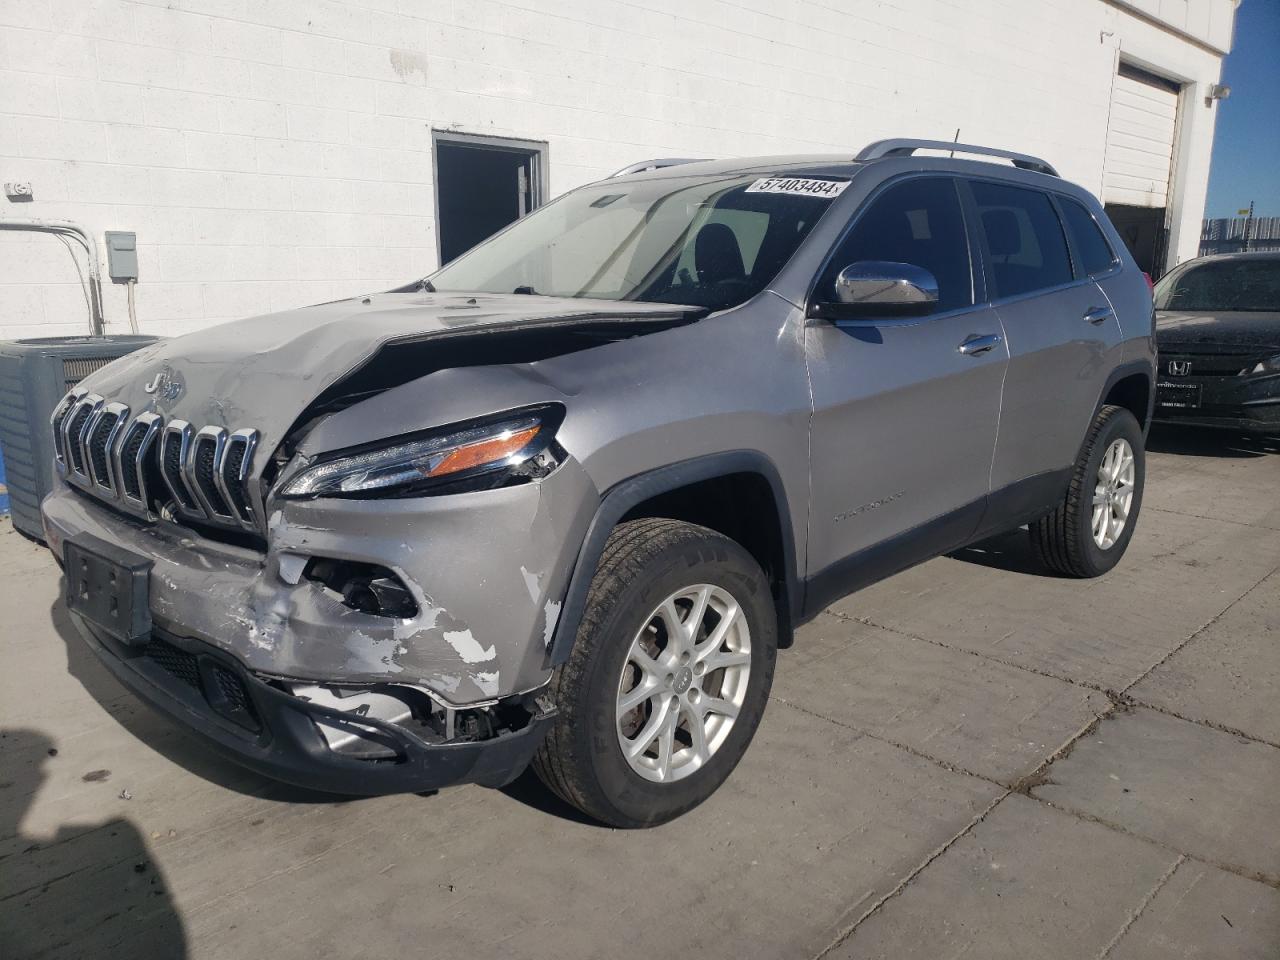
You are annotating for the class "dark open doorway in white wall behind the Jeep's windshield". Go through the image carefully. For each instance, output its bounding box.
[435,134,547,266]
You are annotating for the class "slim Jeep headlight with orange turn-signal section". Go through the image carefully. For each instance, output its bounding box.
[280,407,561,498]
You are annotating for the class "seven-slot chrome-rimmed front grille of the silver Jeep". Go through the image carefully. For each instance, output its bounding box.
[50,393,261,530]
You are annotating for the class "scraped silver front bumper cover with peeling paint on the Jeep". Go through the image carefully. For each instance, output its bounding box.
[42,450,599,707]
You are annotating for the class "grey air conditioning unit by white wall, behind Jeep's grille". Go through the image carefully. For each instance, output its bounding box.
[0,335,157,540]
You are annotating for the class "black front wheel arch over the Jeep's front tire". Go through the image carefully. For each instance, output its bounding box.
[549,451,804,667]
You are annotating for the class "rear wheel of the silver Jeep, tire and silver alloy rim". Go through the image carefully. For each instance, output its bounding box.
[1029,406,1147,577]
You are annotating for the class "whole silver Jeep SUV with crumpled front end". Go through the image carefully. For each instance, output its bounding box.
[44,141,1155,827]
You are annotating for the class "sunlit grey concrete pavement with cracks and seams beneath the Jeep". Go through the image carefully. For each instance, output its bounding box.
[0,433,1280,960]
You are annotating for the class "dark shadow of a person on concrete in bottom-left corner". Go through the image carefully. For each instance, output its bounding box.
[0,728,188,960]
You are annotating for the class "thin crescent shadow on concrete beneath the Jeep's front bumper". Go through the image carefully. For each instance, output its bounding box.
[49,599,353,804]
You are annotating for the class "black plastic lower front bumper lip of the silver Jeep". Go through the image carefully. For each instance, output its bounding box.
[72,614,556,796]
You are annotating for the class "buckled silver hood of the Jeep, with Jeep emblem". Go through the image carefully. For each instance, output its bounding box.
[82,293,703,460]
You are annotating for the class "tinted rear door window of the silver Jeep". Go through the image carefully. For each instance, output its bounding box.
[970,180,1075,297]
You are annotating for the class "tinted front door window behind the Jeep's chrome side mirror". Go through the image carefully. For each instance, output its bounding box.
[818,177,973,311]
